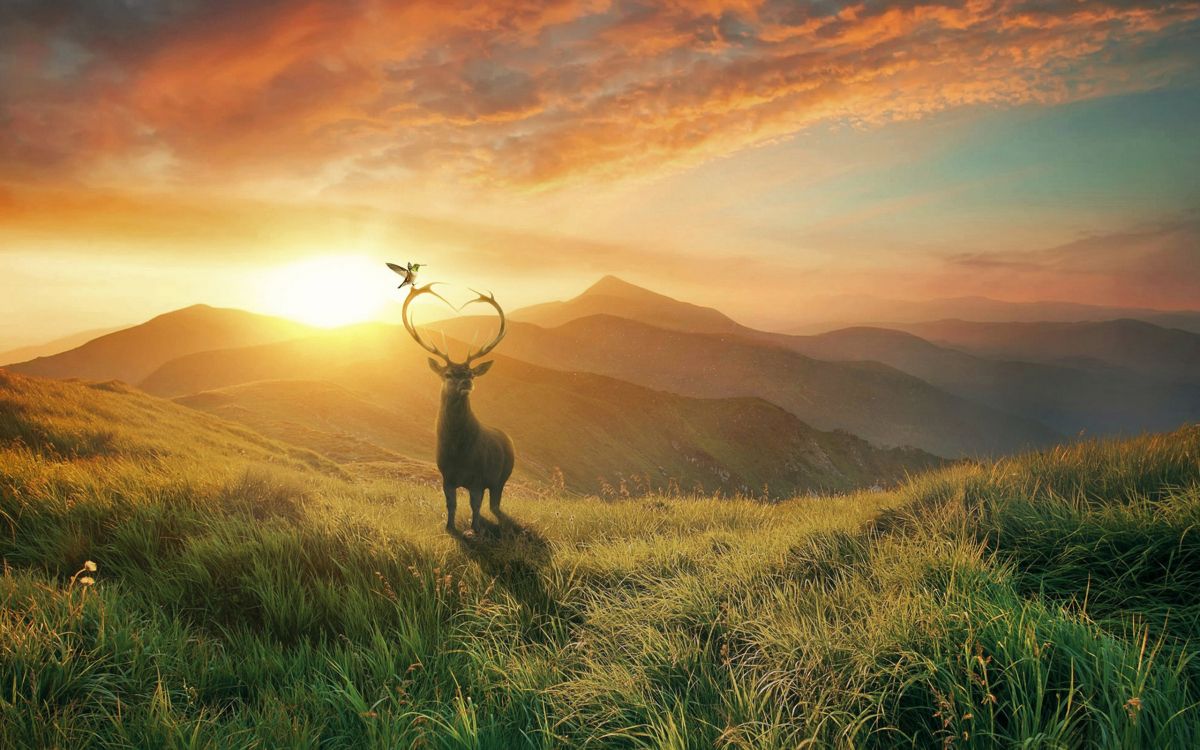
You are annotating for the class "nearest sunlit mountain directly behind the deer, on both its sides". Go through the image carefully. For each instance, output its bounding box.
[142,325,937,494]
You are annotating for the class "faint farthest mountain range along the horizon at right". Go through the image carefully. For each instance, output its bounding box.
[776,294,1200,334]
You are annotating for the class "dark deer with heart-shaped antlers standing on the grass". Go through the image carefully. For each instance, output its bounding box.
[401,283,515,535]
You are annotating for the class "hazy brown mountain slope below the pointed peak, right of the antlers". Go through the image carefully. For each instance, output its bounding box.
[436,316,1062,456]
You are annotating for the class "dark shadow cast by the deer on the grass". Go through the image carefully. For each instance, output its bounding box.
[452,511,577,641]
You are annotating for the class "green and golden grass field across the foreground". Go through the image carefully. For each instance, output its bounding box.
[0,372,1200,749]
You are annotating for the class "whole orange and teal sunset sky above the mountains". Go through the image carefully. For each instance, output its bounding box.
[0,0,1200,347]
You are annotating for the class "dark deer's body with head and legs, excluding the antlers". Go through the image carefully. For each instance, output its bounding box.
[430,359,515,533]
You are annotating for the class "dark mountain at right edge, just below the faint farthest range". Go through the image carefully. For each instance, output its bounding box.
[904,319,1200,383]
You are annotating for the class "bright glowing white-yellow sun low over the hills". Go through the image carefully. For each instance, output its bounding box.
[262,256,395,328]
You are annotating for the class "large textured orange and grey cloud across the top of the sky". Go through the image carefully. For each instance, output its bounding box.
[7,0,1200,191]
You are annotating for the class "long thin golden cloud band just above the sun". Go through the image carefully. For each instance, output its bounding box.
[0,182,710,281]
